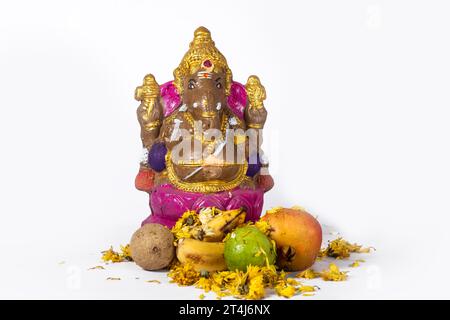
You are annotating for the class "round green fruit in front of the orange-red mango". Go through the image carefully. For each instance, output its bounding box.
[224,226,276,271]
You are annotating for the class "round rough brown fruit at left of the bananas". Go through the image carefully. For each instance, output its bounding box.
[130,223,175,270]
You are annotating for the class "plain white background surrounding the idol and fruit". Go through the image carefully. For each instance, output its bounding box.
[0,0,450,299]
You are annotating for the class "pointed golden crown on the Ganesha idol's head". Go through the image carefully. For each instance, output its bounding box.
[173,27,233,95]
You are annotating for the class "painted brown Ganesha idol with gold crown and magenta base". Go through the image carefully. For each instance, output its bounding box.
[135,27,273,228]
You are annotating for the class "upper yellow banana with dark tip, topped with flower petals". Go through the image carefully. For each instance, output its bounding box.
[191,209,246,242]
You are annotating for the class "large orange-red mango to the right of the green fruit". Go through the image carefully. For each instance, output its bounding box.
[261,208,322,271]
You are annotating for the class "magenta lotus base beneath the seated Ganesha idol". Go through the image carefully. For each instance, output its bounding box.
[142,184,264,228]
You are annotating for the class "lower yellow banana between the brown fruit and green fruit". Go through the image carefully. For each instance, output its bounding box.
[177,238,227,272]
